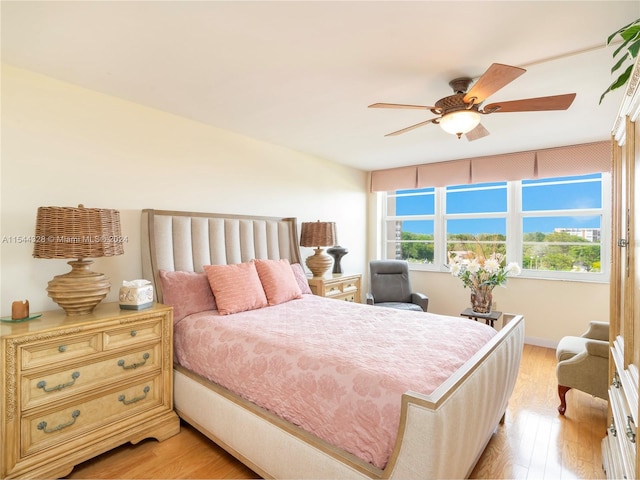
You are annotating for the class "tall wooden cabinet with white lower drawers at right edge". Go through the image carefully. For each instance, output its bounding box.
[602,58,640,479]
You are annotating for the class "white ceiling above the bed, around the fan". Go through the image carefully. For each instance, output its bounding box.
[1,0,640,170]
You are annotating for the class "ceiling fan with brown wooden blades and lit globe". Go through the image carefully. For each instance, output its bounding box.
[369,63,576,141]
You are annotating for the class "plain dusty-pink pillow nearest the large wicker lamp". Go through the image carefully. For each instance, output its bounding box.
[158,270,216,323]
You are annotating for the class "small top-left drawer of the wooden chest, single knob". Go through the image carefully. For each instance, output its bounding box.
[21,333,101,370]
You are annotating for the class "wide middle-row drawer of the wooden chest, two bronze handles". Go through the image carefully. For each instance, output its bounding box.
[22,343,161,410]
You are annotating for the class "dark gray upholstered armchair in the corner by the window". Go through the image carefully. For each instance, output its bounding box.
[367,260,429,312]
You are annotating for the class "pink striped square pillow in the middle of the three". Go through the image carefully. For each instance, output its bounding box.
[204,262,268,315]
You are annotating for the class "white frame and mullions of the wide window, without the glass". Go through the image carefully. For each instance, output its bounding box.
[378,172,611,283]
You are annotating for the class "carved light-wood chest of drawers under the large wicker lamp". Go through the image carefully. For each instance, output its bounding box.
[0,303,180,478]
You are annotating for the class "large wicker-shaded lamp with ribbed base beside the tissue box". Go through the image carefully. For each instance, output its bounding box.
[33,205,124,316]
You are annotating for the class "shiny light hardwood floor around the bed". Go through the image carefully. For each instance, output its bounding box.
[68,345,607,480]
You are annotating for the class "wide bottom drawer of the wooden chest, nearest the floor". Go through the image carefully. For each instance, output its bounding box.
[21,373,163,456]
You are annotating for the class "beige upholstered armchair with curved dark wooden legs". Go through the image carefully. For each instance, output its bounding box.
[556,322,609,415]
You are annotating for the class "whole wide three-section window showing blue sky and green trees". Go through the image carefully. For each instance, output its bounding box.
[384,174,610,281]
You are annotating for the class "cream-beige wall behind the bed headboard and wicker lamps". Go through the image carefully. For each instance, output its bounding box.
[0,65,366,316]
